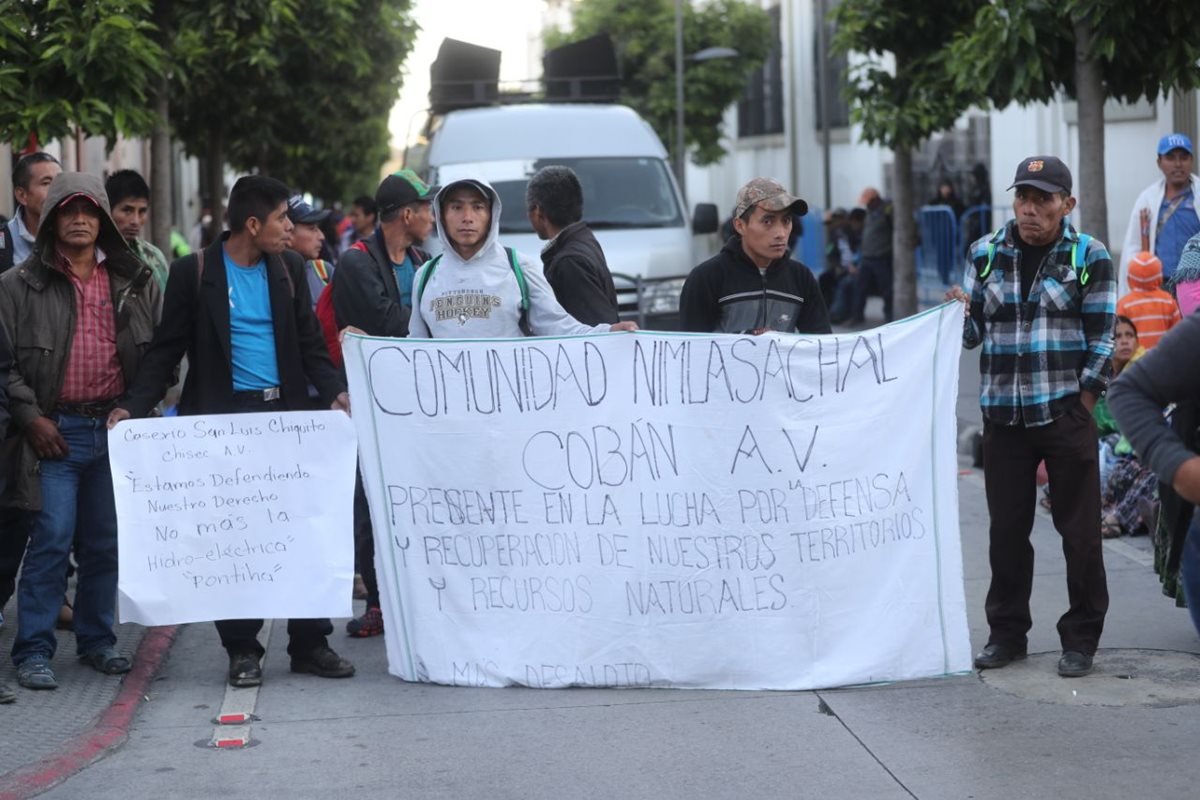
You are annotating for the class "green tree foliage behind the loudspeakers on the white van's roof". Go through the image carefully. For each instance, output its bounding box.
[546,0,770,166]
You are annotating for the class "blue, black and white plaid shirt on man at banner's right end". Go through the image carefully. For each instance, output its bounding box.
[962,222,1117,427]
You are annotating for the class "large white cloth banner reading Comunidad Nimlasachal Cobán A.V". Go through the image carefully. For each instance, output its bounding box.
[344,305,971,690]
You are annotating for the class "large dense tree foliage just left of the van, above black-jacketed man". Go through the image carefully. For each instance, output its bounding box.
[170,0,416,216]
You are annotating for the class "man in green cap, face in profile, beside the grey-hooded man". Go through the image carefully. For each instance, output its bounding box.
[331,169,434,638]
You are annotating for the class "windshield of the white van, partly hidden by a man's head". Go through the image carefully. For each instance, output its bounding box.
[492,157,683,234]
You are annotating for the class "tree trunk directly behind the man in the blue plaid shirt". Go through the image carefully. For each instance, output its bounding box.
[1075,19,1109,243]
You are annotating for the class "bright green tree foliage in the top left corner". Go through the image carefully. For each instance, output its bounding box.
[0,0,163,146]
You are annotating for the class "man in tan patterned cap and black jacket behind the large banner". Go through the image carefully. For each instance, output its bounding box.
[679,178,832,335]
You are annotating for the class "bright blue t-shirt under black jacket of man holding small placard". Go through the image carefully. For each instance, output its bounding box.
[221,248,280,392]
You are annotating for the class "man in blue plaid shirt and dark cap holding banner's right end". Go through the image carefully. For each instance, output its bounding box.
[947,156,1117,678]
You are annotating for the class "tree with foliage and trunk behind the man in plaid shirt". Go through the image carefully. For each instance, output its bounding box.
[950,0,1200,241]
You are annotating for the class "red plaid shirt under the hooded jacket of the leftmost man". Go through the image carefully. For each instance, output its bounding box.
[58,247,125,403]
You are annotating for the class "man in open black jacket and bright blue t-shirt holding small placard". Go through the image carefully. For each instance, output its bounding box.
[108,175,354,686]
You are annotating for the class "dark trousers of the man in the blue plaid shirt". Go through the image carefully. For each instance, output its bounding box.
[983,404,1109,655]
